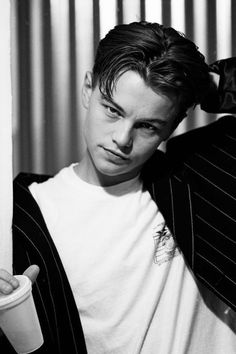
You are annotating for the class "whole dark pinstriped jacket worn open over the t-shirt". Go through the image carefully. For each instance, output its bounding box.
[0,62,236,354]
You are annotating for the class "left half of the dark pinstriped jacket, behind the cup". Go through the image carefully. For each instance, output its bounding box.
[9,174,86,354]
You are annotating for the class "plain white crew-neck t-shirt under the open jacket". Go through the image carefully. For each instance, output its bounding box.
[30,165,236,354]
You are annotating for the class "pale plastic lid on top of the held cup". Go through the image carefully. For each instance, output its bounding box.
[0,274,32,310]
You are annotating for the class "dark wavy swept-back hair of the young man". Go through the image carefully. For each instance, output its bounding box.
[92,21,210,125]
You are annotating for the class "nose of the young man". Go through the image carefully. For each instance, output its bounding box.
[112,121,133,151]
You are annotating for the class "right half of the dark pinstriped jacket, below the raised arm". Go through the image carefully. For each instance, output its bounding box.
[151,116,236,310]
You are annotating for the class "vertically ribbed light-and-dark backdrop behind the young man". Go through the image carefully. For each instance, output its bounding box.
[11,0,236,175]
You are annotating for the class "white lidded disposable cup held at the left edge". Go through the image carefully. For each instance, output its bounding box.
[0,275,43,354]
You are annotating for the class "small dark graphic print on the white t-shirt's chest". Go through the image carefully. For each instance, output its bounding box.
[153,222,180,265]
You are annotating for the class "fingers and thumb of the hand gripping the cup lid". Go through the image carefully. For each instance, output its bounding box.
[0,265,39,295]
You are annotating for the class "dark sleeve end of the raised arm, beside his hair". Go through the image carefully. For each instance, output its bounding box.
[201,57,236,113]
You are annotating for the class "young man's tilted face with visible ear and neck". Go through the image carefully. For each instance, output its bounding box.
[78,71,175,186]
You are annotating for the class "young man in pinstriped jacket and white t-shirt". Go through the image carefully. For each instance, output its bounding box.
[0,22,236,354]
